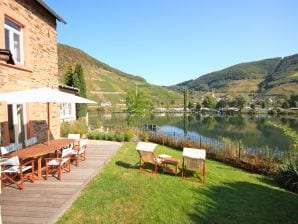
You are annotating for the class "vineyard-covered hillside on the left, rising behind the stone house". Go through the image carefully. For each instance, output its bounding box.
[58,44,182,105]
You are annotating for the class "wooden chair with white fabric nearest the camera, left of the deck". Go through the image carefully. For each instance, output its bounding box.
[1,156,34,190]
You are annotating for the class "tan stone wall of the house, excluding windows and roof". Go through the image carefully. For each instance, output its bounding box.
[0,0,60,144]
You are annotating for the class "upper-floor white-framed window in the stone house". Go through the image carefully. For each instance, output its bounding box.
[4,18,24,64]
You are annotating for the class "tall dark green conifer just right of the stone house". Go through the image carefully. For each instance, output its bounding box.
[73,64,87,118]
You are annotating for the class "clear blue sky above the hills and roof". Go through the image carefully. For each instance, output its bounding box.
[46,0,298,85]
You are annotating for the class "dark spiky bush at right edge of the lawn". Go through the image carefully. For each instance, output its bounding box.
[276,159,298,193]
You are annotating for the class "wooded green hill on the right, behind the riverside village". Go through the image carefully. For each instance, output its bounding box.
[171,54,298,96]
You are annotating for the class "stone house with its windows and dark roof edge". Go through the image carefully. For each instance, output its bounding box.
[0,0,66,145]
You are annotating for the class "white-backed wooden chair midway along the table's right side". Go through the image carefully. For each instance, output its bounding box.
[45,147,72,181]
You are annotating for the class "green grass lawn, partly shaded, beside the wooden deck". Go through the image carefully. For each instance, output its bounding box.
[58,143,298,224]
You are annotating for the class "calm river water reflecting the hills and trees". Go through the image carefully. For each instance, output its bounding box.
[89,113,298,151]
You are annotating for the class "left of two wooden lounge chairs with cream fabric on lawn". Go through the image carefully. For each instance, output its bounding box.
[136,142,162,174]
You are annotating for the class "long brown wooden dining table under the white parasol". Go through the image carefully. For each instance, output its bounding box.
[9,139,75,179]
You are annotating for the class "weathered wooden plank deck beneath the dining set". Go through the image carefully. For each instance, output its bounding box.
[0,140,121,224]
